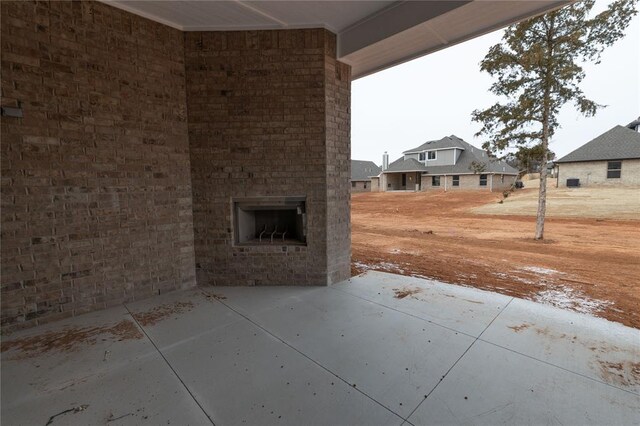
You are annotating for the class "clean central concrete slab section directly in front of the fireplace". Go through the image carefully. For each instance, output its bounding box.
[238,289,474,416]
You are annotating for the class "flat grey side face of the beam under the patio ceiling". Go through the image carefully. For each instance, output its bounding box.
[338,0,472,57]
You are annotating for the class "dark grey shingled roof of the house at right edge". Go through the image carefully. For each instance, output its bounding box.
[556,126,640,163]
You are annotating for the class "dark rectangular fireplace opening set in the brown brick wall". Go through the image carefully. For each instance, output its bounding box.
[233,197,307,245]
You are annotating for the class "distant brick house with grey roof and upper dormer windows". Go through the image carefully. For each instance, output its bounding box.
[373,135,518,191]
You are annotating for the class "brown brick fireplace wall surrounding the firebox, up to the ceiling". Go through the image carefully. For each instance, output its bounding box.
[185,29,350,285]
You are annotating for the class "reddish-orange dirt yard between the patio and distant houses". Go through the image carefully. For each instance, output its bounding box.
[351,189,640,328]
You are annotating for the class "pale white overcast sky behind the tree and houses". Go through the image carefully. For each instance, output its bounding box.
[351,0,640,165]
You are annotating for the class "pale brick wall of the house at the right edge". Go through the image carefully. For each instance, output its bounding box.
[557,159,640,187]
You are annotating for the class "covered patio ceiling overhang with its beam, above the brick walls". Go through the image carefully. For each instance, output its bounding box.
[101,0,571,79]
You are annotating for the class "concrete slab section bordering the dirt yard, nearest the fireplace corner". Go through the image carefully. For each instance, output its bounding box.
[332,271,512,337]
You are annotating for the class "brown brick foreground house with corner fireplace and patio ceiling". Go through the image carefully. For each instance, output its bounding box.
[0,0,567,331]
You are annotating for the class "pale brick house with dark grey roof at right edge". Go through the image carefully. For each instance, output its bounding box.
[556,119,640,187]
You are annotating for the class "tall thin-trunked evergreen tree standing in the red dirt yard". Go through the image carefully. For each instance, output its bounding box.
[472,0,638,240]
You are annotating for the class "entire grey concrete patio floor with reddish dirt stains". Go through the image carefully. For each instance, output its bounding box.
[1,273,640,425]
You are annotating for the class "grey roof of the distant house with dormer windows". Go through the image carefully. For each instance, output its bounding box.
[385,136,518,175]
